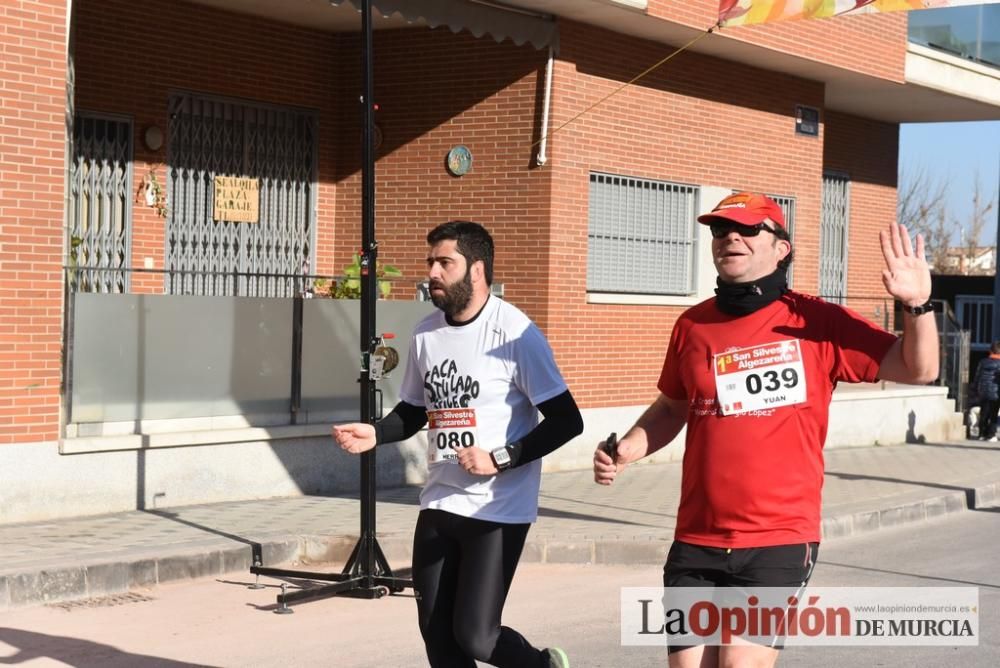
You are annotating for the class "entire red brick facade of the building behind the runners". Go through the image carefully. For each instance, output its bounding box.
[0,0,905,443]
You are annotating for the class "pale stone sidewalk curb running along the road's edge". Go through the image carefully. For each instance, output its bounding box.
[0,482,1000,612]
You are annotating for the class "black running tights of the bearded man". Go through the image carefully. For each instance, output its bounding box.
[413,510,548,668]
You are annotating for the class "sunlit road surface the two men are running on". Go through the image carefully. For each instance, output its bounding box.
[0,508,1000,668]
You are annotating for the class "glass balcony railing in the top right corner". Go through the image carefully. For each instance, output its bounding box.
[909,4,1000,67]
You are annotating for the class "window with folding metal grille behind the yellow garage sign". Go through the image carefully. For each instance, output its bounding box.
[165,94,317,297]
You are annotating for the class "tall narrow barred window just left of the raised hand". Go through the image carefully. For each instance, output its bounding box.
[819,173,851,304]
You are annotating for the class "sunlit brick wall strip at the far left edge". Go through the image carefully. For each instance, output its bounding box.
[0,0,66,443]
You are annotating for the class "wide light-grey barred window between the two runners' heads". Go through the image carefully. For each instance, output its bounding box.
[587,173,698,295]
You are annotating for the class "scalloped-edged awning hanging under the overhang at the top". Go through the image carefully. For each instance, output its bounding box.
[330,0,557,49]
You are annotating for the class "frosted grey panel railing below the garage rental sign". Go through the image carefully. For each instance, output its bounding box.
[64,267,434,437]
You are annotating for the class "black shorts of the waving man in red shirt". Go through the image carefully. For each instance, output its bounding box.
[663,541,819,652]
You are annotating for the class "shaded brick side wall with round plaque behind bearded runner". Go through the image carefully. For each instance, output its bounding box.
[335,30,550,314]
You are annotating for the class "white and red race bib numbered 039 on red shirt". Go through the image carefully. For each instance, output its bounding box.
[714,339,806,415]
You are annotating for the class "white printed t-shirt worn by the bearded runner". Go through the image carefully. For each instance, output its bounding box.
[399,297,566,524]
